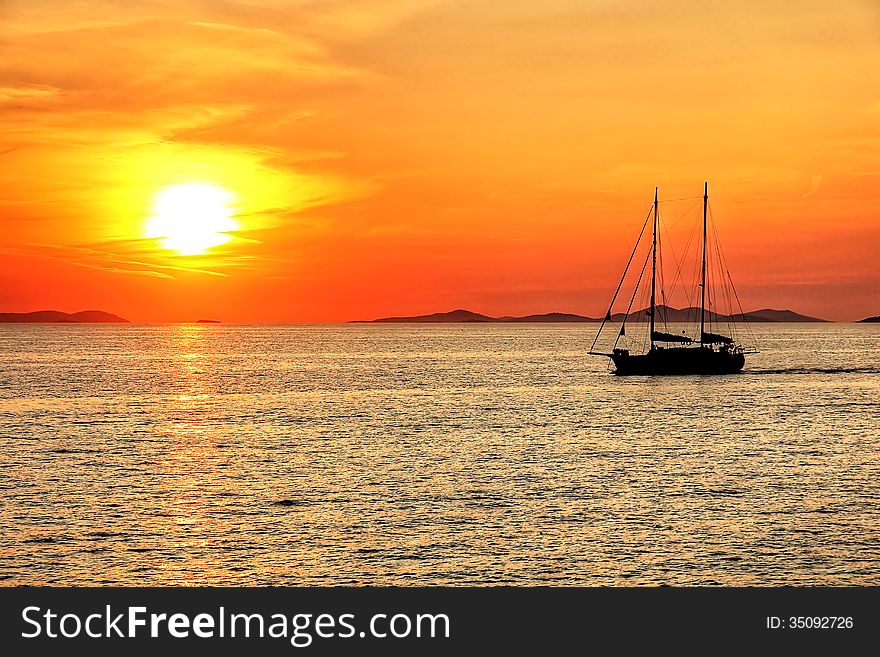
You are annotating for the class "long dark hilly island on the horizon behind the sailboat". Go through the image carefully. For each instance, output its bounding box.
[349,306,824,324]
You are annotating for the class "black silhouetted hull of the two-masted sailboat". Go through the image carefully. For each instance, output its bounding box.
[611,347,746,376]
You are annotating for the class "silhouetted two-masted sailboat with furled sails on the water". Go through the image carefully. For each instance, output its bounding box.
[589,183,756,375]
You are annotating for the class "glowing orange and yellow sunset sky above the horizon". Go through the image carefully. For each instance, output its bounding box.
[0,0,880,322]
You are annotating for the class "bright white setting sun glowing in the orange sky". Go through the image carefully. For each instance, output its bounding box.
[145,183,238,255]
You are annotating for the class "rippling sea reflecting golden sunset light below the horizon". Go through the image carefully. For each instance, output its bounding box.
[0,324,880,586]
